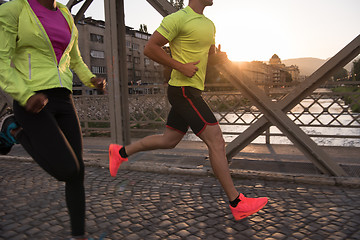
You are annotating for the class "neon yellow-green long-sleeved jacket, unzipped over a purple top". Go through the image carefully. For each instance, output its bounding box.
[0,0,95,106]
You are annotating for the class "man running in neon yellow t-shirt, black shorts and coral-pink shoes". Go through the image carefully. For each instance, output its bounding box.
[109,0,268,220]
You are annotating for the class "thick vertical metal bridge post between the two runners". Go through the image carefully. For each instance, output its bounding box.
[105,0,131,145]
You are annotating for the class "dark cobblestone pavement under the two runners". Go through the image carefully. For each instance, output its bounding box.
[0,160,360,240]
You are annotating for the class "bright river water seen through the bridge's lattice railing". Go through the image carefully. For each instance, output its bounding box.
[185,99,360,147]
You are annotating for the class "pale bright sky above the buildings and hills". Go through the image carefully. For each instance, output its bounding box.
[58,0,360,61]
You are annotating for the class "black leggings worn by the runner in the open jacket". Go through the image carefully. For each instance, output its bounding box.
[14,88,85,236]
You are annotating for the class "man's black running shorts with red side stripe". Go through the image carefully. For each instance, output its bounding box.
[166,85,218,135]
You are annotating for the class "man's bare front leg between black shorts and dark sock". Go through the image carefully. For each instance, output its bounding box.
[199,125,239,201]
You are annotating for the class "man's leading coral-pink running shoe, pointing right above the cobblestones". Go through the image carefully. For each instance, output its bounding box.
[230,193,268,221]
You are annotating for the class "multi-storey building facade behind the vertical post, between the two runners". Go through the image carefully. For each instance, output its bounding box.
[74,18,164,94]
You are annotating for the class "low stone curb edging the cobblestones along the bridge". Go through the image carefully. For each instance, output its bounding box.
[0,156,360,188]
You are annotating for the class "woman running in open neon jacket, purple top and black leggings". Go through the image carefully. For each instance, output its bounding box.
[0,0,106,239]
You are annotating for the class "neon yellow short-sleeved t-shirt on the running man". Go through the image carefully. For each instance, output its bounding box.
[156,6,216,90]
